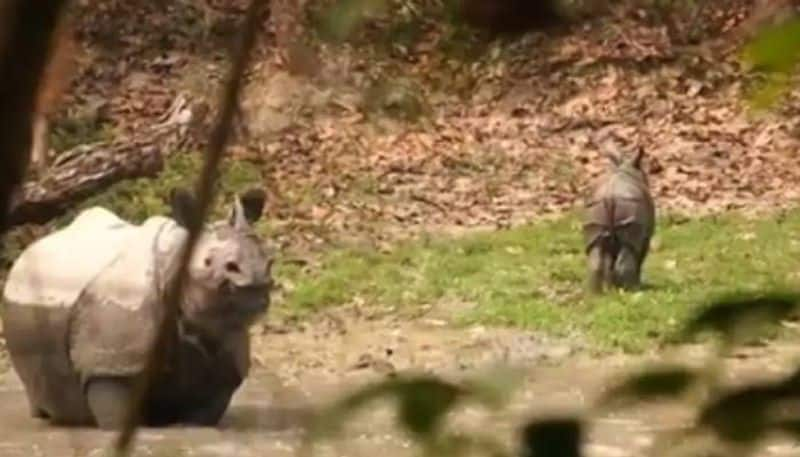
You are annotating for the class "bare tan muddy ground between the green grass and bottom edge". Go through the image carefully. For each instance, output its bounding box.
[0,310,800,457]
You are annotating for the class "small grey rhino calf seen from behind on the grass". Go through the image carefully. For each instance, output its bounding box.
[583,148,655,293]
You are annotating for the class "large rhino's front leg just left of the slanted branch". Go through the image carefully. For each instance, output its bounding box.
[86,377,133,430]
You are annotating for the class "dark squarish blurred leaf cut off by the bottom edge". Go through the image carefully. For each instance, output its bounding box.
[521,417,583,457]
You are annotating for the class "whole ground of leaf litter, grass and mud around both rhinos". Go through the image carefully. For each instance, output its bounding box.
[0,0,800,457]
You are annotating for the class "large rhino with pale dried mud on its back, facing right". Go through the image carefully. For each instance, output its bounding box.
[2,185,272,429]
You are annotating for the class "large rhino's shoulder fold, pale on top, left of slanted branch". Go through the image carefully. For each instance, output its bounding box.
[69,217,186,378]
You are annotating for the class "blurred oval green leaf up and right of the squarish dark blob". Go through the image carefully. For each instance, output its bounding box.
[599,366,698,408]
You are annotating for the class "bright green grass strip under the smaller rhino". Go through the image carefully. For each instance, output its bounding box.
[279,210,800,351]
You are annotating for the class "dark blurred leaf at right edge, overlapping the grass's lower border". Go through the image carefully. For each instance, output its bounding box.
[684,292,800,339]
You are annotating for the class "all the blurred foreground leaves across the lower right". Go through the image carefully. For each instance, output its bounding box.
[305,293,800,457]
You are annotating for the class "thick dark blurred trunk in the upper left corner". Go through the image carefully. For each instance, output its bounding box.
[0,0,68,239]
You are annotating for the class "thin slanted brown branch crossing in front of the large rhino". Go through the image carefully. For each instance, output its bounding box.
[115,0,266,455]
